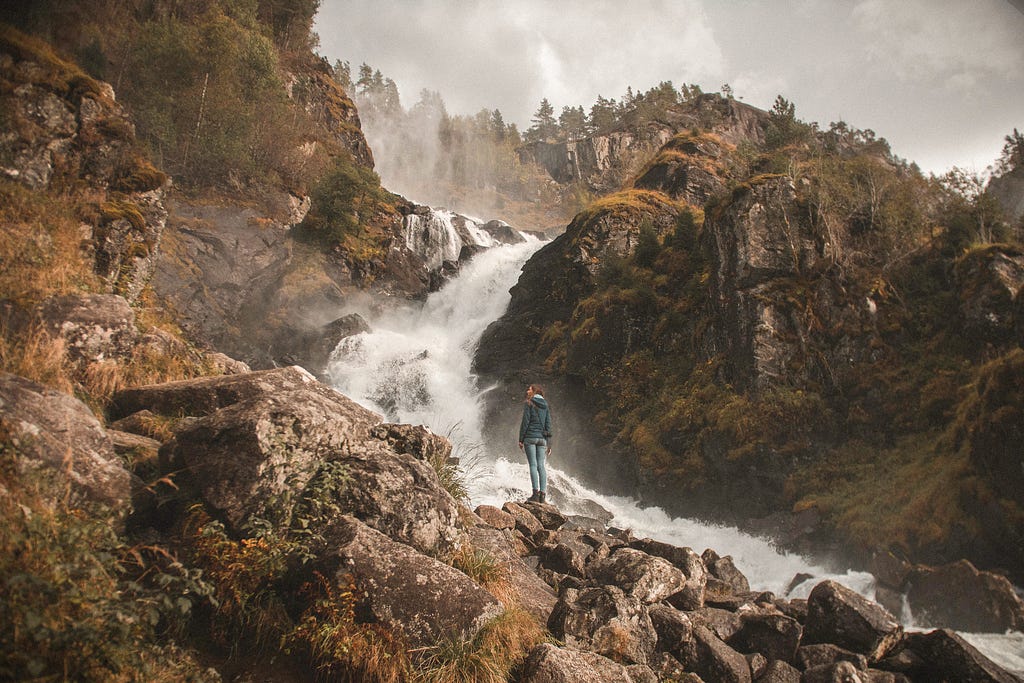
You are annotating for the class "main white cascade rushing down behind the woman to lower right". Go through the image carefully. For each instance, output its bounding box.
[328,235,1024,673]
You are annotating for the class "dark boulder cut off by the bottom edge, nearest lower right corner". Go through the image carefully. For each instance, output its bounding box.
[906,629,1019,683]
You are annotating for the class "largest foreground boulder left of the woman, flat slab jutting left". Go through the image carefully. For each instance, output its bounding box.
[128,368,461,557]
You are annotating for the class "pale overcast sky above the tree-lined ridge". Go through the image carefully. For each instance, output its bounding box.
[316,0,1024,174]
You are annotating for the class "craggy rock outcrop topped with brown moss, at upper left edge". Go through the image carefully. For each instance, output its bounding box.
[0,26,168,302]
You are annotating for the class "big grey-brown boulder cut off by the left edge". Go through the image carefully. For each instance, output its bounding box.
[0,373,131,525]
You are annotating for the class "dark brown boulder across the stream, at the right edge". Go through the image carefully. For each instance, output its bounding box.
[906,560,1024,633]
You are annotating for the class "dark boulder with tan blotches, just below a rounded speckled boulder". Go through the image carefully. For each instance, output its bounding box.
[548,586,657,664]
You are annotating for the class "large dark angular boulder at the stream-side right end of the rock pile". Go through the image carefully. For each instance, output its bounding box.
[803,581,903,661]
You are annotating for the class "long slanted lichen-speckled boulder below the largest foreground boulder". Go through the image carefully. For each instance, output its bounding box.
[326,516,504,647]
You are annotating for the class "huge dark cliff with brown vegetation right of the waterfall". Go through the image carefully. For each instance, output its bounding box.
[476,105,1024,575]
